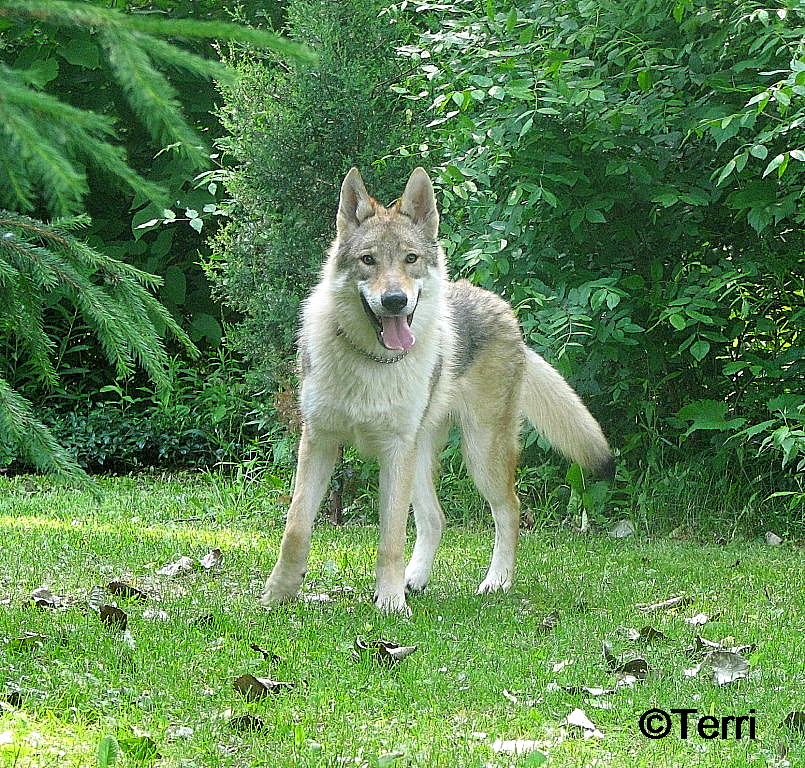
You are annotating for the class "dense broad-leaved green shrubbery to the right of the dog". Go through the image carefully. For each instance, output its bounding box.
[397,0,805,487]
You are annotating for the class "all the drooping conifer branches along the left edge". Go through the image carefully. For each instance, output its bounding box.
[0,0,312,483]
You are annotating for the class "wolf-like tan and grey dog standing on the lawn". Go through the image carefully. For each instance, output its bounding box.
[262,168,614,615]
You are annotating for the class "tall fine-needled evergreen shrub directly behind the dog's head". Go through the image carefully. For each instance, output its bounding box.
[207,0,428,388]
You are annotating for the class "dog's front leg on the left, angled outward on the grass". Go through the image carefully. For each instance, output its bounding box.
[262,427,338,605]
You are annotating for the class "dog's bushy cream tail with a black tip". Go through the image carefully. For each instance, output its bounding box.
[520,347,615,478]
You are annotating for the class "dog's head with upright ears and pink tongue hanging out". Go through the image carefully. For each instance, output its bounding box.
[334,168,443,350]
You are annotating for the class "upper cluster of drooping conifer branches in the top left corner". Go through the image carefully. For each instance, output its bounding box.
[0,0,313,216]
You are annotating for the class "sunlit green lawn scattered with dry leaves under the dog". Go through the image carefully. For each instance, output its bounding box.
[0,476,805,768]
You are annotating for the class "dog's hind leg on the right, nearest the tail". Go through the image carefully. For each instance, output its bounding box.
[462,414,520,594]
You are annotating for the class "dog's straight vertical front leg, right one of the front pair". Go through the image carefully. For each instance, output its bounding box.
[375,444,414,616]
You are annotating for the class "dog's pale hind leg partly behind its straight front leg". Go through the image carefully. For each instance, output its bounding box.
[405,433,444,592]
